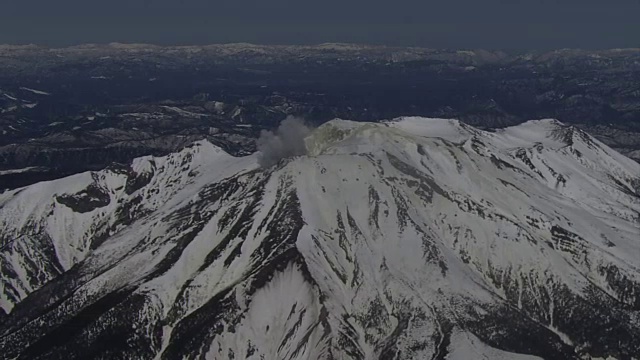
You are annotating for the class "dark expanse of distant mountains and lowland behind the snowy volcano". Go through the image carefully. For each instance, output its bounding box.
[0,44,640,191]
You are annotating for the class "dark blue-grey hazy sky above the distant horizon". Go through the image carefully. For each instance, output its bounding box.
[0,0,640,49]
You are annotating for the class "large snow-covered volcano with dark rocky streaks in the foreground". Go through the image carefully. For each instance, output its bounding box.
[0,118,640,359]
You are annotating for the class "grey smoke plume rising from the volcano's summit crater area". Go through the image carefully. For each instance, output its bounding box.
[256,116,313,167]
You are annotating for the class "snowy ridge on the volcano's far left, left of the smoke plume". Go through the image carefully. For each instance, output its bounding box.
[0,140,256,310]
